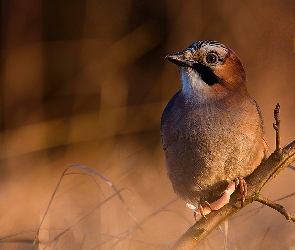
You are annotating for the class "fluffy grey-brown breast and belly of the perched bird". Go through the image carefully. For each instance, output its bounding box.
[161,98,263,206]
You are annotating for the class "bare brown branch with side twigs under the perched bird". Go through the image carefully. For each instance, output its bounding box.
[173,104,295,250]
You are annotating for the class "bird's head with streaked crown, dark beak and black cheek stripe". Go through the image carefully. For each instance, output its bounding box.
[166,40,247,101]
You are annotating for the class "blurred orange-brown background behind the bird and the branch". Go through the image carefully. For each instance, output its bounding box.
[0,0,295,249]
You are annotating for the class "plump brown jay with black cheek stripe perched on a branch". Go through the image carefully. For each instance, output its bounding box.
[160,40,268,216]
